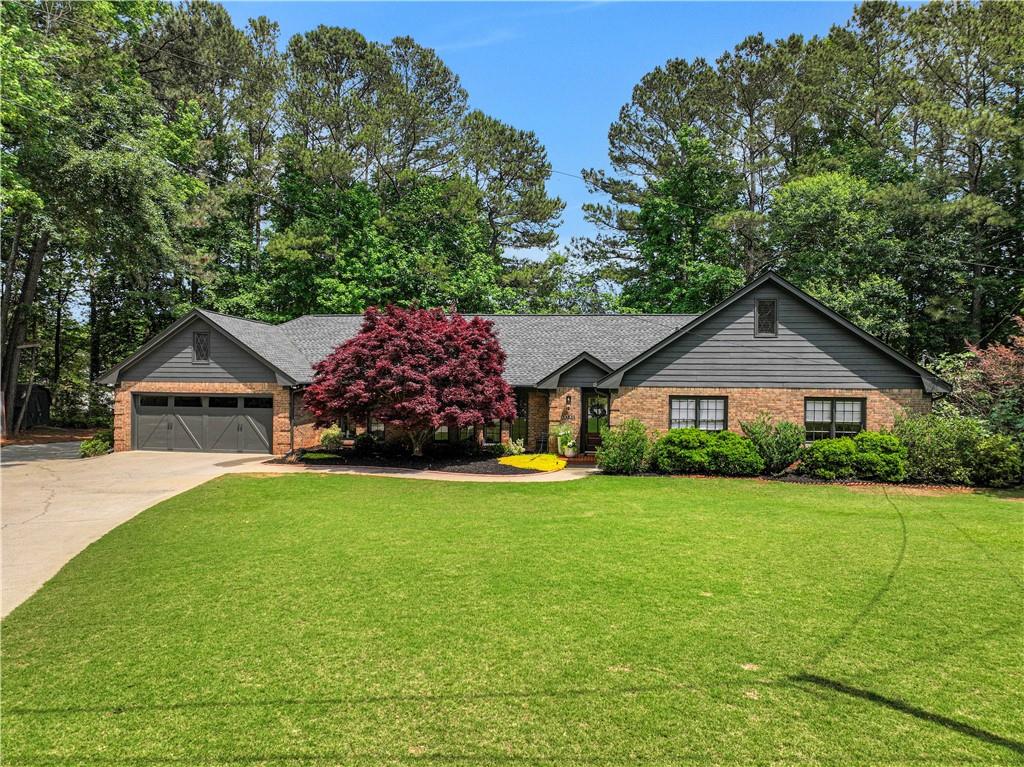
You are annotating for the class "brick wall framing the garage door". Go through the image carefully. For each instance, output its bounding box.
[114,381,292,456]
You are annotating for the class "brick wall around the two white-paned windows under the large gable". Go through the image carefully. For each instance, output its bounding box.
[611,386,932,432]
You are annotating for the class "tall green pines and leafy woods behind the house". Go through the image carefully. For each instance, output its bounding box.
[0,0,1024,428]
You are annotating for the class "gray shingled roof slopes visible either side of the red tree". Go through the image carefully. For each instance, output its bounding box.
[251,312,695,386]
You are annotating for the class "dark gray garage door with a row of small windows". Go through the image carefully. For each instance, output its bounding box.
[132,394,273,453]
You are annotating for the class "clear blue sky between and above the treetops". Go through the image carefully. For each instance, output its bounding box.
[224,2,854,257]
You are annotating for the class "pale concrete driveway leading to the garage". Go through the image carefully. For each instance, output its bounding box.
[0,442,272,615]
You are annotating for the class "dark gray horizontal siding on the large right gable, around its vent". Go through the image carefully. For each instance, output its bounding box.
[623,286,922,389]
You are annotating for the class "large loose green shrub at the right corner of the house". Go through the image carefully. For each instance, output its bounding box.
[894,411,986,484]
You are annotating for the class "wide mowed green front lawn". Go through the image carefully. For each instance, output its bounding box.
[2,475,1024,765]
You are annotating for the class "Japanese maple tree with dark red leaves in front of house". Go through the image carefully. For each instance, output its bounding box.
[305,306,515,456]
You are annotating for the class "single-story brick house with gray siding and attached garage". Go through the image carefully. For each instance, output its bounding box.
[101,273,949,454]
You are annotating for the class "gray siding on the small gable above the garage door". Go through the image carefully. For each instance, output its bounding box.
[121,321,276,383]
